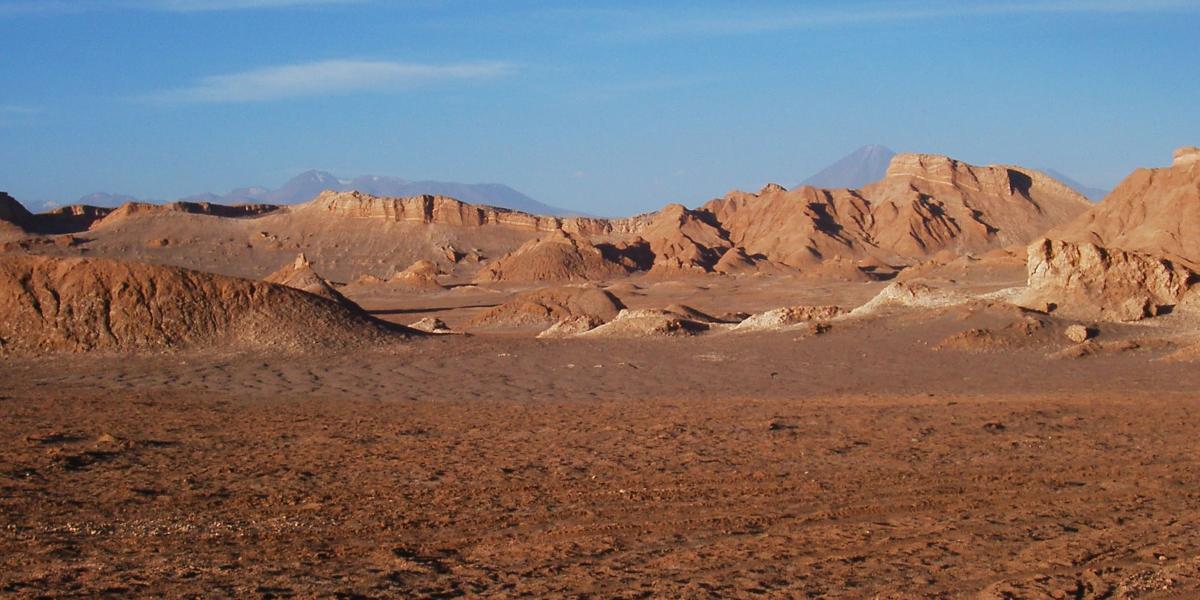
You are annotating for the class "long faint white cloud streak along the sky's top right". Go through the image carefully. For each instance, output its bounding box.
[600,0,1200,38]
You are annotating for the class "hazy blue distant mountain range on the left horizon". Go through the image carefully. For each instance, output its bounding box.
[50,170,577,216]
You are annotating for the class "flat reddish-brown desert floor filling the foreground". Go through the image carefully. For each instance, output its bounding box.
[0,276,1200,598]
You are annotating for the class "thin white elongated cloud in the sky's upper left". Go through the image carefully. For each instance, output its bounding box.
[140,60,516,103]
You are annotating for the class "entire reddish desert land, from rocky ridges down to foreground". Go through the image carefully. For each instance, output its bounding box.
[0,148,1200,599]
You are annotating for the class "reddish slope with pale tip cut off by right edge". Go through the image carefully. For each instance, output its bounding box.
[1045,149,1200,271]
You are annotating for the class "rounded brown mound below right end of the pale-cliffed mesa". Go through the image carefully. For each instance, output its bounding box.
[474,229,630,283]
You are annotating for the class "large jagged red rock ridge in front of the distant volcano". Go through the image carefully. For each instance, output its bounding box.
[703,155,1091,271]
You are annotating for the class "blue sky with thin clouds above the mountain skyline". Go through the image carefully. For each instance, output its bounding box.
[0,0,1200,215]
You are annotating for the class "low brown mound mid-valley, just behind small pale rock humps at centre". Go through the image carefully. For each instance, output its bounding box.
[470,284,625,328]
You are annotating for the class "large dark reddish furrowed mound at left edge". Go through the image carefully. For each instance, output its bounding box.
[0,256,402,354]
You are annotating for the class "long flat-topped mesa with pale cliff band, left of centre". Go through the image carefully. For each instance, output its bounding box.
[294,191,628,235]
